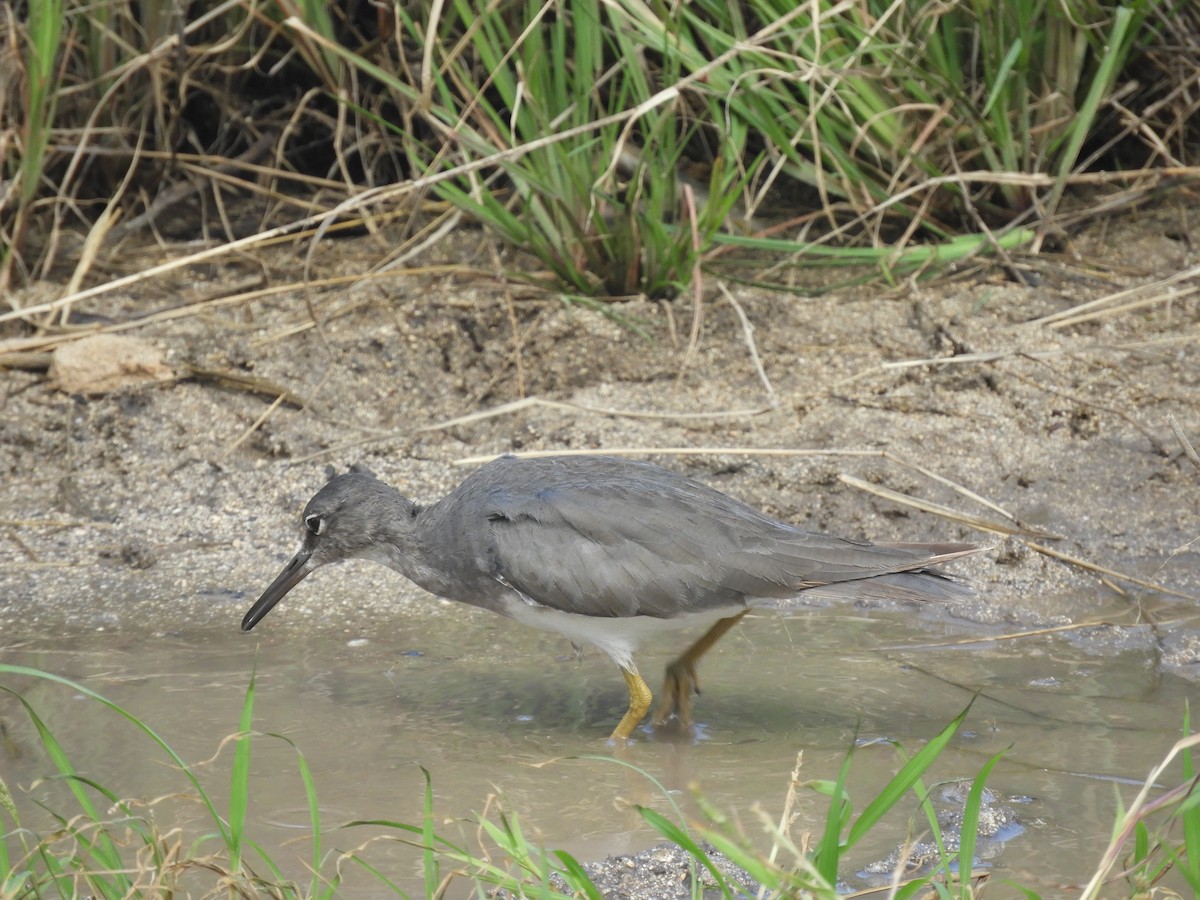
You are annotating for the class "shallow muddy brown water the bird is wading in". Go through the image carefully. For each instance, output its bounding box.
[0,602,1194,896]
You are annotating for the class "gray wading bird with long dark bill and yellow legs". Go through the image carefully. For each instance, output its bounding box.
[241,456,979,739]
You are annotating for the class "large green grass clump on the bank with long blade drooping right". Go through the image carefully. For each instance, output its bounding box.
[278,0,1032,296]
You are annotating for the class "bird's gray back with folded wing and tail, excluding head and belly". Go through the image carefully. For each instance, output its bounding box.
[420,456,977,618]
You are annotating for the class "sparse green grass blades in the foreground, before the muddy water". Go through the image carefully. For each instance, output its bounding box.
[0,665,1200,900]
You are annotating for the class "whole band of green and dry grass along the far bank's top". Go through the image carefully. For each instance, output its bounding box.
[0,0,1200,303]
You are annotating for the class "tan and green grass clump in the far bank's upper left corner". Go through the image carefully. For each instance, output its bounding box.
[0,0,261,300]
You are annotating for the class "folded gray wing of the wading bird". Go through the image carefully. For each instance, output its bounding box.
[477,479,976,618]
